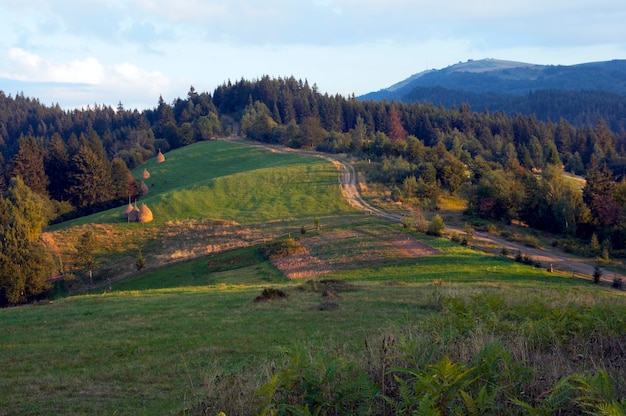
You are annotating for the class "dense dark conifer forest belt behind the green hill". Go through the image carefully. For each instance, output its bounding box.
[0,76,626,304]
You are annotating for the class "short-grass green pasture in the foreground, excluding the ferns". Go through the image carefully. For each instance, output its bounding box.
[0,224,626,415]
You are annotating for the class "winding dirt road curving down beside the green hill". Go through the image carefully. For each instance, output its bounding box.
[227,138,626,284]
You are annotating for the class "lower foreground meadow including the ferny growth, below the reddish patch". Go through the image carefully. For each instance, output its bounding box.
[0,239,626,415]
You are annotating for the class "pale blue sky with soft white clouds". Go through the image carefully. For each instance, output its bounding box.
[0,0,626,110]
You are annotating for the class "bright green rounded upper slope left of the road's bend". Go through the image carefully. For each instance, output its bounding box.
[51,141,351,230]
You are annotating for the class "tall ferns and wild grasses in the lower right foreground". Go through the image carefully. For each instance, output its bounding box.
[200,287,626,415]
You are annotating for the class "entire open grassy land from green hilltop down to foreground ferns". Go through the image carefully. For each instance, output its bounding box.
[0,141,626,415]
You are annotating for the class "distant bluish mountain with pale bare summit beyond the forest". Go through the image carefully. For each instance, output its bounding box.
[359,59,626,132]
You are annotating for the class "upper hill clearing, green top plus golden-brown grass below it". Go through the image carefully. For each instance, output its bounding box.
[42,141,360,293]
